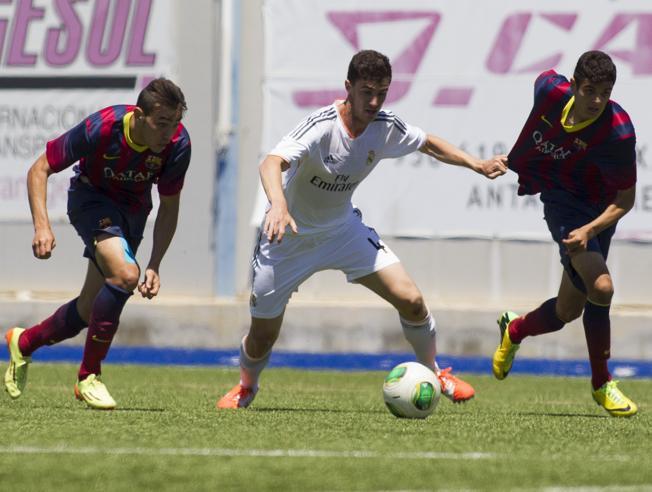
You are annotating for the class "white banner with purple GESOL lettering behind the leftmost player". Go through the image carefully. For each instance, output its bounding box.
[0,0,175,220]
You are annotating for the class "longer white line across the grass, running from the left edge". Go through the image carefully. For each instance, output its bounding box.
[0,446,496,460]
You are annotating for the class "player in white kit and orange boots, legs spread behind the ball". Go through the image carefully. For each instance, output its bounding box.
[217,50,507,408]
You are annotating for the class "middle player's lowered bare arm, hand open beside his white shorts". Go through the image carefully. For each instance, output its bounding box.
[259,155,297,243]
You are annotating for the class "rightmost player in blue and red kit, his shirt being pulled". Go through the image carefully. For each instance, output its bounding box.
[493,51,637,417]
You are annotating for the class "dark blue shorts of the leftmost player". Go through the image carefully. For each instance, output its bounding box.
[68,181,148,271]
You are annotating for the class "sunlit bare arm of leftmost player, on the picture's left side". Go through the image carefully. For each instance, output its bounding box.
[27,154,57,260]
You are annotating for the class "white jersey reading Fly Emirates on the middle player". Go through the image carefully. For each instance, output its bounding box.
[269,102,426,234]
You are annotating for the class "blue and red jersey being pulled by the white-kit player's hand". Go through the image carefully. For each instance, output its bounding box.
[508,70,636,204]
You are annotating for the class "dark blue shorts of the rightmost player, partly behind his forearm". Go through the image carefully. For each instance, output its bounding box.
[541,190,616,293]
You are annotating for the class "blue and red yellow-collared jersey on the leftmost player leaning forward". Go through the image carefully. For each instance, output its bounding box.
[46,105,190,212]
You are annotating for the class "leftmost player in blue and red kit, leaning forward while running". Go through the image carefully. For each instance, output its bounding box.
[4,79,190,409]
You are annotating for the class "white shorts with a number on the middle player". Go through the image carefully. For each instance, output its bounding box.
[249,209,400,319]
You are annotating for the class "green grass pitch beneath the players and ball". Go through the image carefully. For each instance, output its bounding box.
[0,364,652,492]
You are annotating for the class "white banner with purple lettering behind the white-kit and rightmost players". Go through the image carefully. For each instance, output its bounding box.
[262,0,652,240]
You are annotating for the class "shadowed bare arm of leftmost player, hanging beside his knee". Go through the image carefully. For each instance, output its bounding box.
[138,193,181,299]
